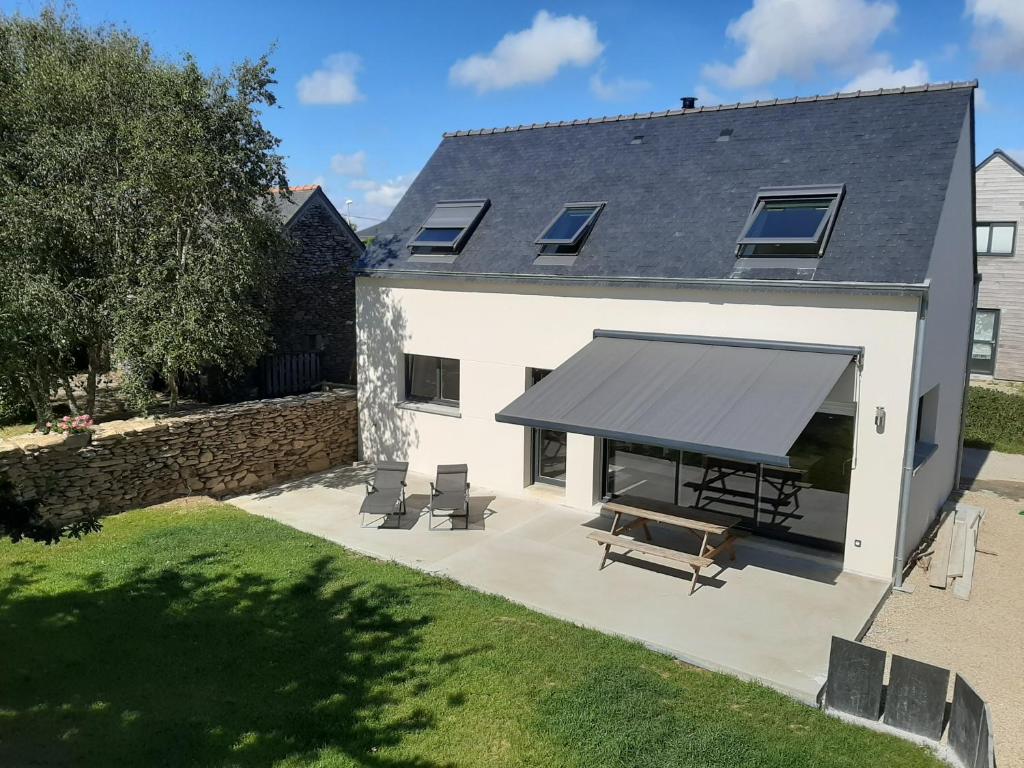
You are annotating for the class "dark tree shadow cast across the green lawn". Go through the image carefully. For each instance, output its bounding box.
[0,552,473,768]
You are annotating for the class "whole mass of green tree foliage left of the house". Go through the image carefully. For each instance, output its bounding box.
[0,4,287,421]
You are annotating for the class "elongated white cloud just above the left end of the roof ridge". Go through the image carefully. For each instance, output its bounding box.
[449,10,604,93]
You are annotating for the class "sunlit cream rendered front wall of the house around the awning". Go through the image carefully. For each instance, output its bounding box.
[356,278,918,580]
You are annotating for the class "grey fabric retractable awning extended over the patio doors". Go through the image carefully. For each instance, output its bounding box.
[495,331,860,466]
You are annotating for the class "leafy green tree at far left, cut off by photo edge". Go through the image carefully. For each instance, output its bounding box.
[0,9,152,423]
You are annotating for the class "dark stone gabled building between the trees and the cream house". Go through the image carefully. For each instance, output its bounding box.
[272,184,364,383]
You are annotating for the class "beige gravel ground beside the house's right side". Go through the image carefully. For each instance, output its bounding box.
[864,492,1024,767]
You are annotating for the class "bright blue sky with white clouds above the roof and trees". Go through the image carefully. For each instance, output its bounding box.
[6,0,1024,226]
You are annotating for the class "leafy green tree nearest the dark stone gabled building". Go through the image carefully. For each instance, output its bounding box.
[116,56,288,411]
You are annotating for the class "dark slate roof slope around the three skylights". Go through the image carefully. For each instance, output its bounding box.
[360,82,977,283]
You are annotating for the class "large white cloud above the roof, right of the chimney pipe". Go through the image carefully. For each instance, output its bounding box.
[703,0,897,88]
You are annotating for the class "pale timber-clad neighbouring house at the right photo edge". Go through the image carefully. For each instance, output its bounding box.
[971,150,1024,381]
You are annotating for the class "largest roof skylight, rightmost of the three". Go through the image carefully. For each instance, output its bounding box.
[737,186,845,257]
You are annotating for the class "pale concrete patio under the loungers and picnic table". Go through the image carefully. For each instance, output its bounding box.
[230,466,888,702]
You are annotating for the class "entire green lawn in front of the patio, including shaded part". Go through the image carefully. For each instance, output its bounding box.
[0,505,941,768]
